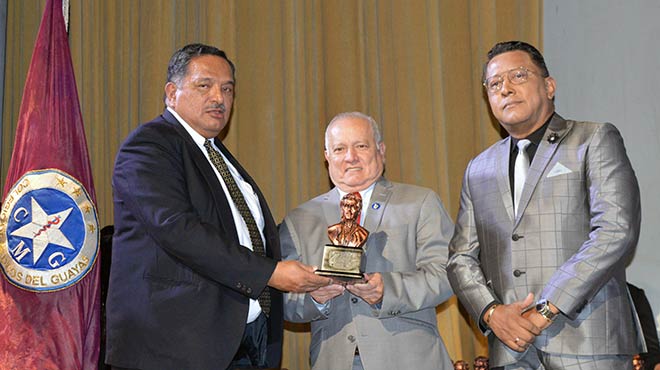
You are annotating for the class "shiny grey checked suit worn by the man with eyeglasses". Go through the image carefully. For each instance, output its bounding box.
[447,114,643,366]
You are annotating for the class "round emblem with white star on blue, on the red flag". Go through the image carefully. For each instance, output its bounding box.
[0,169,99,292]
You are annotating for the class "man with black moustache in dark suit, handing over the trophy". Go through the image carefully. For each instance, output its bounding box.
[106,44,330,369]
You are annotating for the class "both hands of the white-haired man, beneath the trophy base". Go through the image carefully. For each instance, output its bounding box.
[309,272,383,305]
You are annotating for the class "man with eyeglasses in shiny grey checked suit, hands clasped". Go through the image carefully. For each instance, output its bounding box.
[447,41,644,370]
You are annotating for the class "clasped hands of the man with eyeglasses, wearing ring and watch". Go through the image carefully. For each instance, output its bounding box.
[484,293,552,352]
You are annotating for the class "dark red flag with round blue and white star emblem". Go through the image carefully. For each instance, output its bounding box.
[0,0,100,369]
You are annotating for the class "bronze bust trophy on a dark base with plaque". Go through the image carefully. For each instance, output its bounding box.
[316,193,369,284]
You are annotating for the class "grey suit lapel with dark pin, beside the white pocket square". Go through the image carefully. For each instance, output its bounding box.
[514,113,572,227]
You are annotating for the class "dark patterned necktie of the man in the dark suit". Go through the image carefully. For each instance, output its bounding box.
[204,140,270,315]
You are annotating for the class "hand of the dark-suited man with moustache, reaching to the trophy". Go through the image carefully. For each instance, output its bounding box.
[268,261,332,293]
